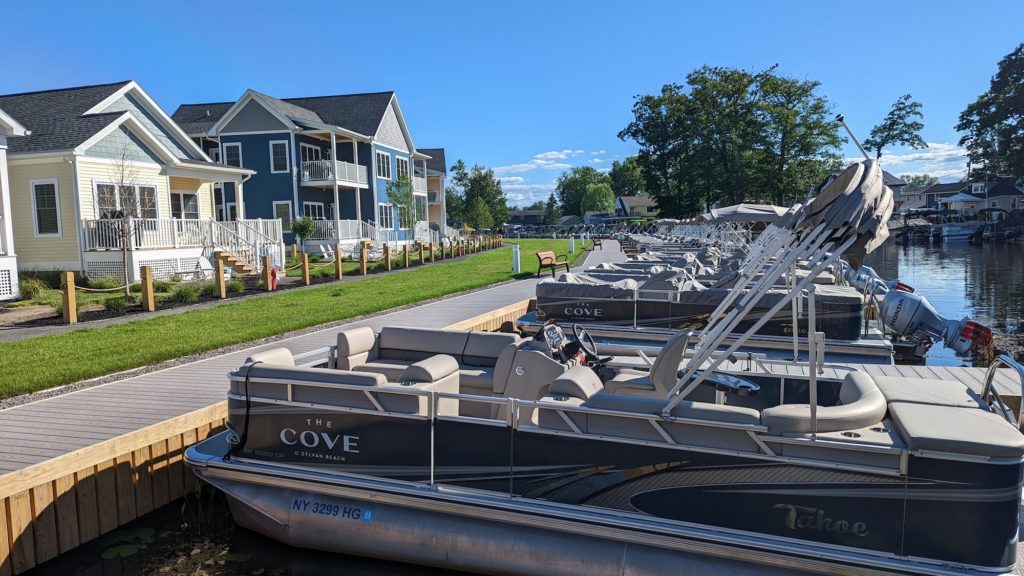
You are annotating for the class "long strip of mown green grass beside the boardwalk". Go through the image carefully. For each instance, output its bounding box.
[0,240,583,398]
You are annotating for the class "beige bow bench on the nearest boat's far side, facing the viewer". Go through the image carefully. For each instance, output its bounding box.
[336,326,520,396]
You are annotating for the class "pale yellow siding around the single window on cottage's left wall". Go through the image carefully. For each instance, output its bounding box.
[8,160,80,270]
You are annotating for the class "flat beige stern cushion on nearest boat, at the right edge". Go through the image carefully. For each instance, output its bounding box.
[889,402,1024,458]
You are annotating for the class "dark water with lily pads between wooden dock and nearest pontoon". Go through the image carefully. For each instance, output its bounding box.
[25,487,465,576]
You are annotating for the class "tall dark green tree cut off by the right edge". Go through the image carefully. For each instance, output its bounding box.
[956,44,1024,178]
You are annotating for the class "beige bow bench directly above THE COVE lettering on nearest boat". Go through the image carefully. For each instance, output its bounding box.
[230,348,459,415]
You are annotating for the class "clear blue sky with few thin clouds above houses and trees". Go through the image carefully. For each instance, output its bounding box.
[0,0,1024,204]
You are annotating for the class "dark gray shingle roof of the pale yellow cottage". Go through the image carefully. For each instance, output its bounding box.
[0,81,129,154]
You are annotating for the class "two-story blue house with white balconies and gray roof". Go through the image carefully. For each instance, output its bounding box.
[173,89,444,244]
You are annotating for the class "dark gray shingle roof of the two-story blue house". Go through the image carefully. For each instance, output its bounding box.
[171,90,394,136]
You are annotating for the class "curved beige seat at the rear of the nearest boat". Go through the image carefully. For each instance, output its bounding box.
[761,372,887,435]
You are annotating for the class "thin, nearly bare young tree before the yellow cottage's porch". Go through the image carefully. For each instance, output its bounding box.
[96,145,159,299]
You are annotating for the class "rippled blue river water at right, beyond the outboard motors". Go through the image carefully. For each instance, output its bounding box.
[864,240,1024,366]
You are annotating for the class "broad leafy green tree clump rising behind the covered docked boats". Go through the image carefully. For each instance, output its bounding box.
[618,67,843,216]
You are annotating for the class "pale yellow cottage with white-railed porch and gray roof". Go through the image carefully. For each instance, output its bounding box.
[0,81,284,280]
